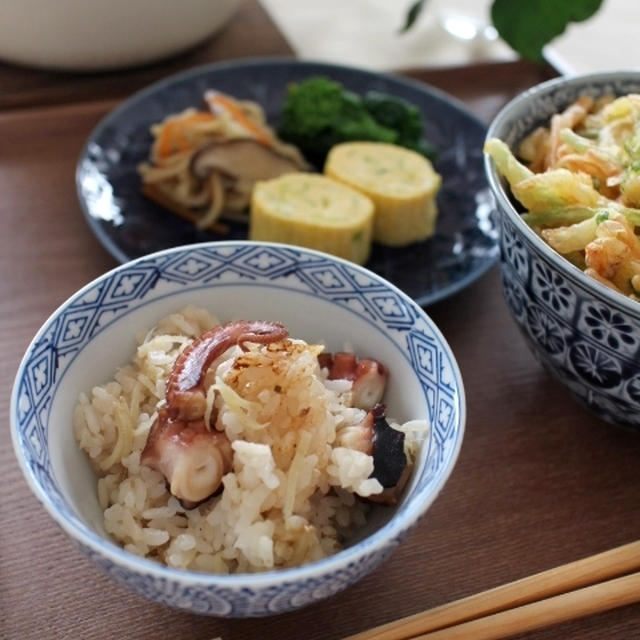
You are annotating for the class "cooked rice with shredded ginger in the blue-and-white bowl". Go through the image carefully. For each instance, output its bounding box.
[73,307,427,573]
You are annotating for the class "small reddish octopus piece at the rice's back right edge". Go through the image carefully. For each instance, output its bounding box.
[318,351,389,410]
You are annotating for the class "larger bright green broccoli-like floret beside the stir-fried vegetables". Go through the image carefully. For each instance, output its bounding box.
[278,76,398,165]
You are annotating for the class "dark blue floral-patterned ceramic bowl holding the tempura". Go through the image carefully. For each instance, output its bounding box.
[485,71,640,429]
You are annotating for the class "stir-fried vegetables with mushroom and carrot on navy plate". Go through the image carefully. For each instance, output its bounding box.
[139,90,308,233]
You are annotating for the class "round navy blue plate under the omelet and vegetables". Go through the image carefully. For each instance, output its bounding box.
[76,58,498,306]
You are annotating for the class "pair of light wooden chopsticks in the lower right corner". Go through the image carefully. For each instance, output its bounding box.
[344,541,640,640]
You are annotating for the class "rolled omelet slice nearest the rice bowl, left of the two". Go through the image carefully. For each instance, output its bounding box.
[249,173,374,264]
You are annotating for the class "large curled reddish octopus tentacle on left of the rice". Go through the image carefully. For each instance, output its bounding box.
[140,321,288,509]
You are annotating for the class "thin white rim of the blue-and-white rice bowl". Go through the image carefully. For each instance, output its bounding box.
[10,240,467,590]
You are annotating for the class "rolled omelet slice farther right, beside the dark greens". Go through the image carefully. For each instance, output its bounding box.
[324,142,442,247]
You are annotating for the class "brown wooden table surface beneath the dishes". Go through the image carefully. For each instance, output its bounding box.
[0,1,640,640]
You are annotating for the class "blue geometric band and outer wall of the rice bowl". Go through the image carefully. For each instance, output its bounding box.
[12,242,465,617]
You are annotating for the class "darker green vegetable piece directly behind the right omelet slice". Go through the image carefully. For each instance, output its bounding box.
[363,91,436,159]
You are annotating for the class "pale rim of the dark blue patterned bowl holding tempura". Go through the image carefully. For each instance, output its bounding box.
[484,67,640,315]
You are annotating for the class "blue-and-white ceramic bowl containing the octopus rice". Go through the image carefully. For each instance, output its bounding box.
[11,242,465,617]
